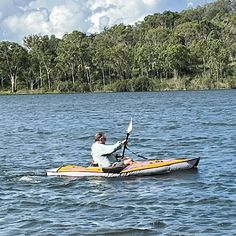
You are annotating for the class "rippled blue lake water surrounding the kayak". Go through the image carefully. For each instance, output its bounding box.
[0,90,236,236]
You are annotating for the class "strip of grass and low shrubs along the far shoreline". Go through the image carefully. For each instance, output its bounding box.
[0,77,236,95]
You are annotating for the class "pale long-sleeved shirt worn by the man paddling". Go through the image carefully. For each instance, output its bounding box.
[91,142,122,167]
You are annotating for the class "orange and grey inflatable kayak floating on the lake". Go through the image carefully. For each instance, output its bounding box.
[47,157,200,177]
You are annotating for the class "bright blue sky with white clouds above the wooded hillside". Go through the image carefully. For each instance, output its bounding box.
[0,0,215,43]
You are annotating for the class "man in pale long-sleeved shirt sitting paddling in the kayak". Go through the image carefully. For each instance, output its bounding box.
[91,132,133,167]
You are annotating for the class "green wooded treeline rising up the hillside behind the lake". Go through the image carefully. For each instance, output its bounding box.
[0,0,236,93]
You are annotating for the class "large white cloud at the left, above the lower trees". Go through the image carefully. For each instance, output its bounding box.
[1,0,91,41]
